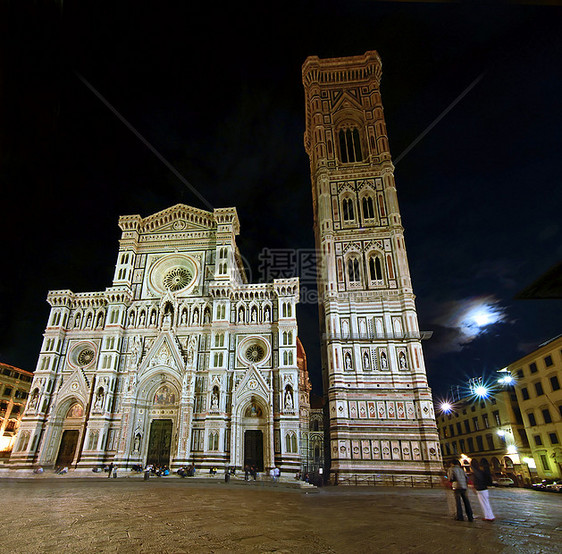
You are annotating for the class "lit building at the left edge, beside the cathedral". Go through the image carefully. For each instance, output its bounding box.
[0,363,33,458]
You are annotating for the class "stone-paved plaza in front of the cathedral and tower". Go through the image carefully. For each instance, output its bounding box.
[0,476,562,554]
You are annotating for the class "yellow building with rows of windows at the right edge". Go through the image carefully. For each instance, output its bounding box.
[507,336,562,479]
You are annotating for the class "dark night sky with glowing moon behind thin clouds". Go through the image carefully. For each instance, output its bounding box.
[0,0,562,396]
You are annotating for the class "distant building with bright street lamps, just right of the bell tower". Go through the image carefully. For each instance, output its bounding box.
[437,387,536,485]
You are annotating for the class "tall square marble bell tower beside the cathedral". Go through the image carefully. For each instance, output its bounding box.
[302,51,442,485]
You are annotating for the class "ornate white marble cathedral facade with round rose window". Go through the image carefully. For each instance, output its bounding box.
[11,204,310,472]
